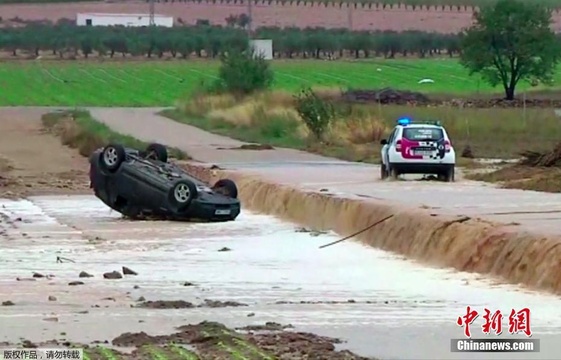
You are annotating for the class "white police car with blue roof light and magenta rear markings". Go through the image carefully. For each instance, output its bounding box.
[380,118,456,182]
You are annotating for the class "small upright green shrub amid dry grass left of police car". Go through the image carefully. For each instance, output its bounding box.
[295,88,335,140]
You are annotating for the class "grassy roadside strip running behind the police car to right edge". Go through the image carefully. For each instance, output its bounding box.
[164,92,561,162]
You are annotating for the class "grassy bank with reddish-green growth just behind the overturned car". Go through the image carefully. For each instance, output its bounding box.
[42,110,189,160]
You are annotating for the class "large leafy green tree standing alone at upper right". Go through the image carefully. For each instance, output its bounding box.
[460,0,561,100]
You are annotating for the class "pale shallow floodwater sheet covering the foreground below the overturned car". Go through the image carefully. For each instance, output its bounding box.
[0,196,561,359]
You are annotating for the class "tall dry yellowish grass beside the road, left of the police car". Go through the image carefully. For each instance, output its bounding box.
[171,88,391,162]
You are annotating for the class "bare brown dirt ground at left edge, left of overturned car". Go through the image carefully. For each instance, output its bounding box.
[0,108,89,198]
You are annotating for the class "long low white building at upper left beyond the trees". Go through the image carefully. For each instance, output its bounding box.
[76,13,173,27]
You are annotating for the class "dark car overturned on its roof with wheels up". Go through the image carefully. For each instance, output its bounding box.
[90,144,240,221]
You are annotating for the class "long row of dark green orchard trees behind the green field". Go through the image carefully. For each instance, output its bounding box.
[0,23,459,59]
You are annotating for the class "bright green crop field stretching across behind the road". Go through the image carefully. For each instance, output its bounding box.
[0,59,561,106]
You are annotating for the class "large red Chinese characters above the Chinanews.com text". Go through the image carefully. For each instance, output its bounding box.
[456,306,532,338]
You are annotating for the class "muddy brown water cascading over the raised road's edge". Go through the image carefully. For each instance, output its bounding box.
[180,165,561,294]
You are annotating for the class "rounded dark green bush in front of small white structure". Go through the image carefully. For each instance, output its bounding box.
[213,50,273,96]
